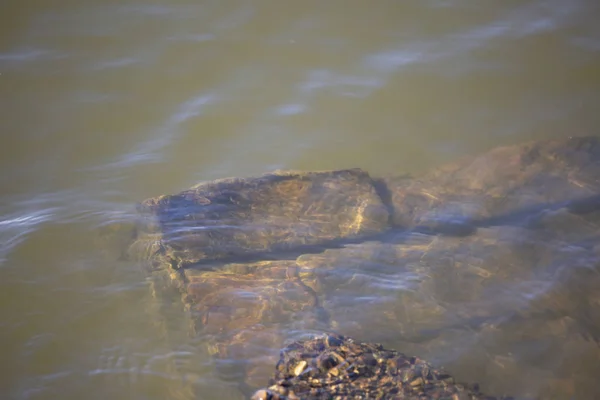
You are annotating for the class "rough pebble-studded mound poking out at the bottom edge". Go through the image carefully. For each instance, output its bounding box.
[252,334,510,400]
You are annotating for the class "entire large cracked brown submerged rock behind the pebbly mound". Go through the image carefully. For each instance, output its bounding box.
[129,137,600,398]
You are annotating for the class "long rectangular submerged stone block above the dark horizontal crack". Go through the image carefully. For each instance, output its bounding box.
[128,169,389,268]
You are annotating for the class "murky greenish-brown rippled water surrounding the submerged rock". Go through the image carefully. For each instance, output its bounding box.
[0,0,600,399]
